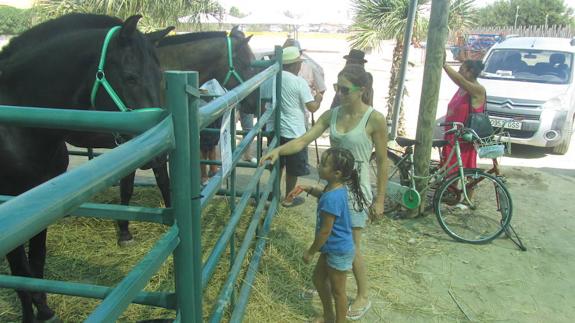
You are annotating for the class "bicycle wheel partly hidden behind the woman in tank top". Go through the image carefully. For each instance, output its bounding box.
[369,151,409,213]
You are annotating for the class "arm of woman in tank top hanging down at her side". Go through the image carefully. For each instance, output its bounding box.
[370,111,388,218]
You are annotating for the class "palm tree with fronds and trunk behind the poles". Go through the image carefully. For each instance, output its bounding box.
[349,0,475,135]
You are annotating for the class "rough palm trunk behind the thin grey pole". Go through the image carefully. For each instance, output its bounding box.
[387,39,406,136]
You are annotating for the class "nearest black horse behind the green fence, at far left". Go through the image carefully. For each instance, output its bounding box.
[0,15,168,322]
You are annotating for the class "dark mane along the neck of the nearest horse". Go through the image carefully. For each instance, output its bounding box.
[0,13,122,60]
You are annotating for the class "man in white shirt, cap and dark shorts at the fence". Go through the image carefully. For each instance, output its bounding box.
[270,46,323,207]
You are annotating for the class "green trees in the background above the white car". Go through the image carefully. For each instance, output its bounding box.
[479,0,573,26]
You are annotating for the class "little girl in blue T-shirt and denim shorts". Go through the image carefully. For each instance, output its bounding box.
[290,148,367,322]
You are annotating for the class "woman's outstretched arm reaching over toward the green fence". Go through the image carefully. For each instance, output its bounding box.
[260,111,331,165]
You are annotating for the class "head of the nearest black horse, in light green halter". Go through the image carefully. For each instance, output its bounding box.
[94,15,169,110]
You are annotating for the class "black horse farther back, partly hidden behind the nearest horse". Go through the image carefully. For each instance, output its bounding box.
[100,27,258,245]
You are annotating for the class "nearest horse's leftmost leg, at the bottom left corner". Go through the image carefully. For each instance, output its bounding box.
[6,246,34,323]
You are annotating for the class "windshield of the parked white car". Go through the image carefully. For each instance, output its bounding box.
[480,49,573,84]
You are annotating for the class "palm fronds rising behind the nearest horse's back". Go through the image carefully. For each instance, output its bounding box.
[35,0,223,30]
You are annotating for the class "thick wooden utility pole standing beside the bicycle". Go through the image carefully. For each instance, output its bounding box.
[409,0,449,216]
